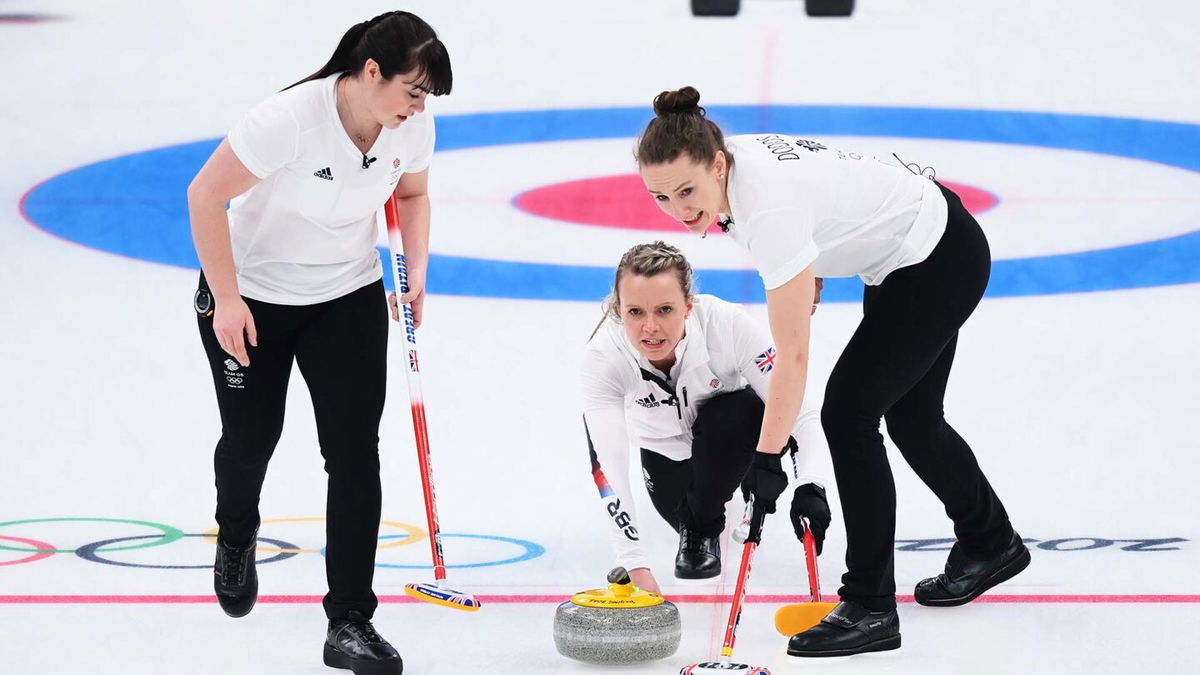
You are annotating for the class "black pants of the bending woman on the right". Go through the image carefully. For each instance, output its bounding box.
[821,187,1013,610]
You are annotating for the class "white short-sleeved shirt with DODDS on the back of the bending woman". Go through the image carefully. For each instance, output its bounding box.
[726,133,947,291]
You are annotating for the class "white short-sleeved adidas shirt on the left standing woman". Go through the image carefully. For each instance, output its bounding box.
[229,74,434,305]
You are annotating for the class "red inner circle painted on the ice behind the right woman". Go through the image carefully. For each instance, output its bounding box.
[512,174,1000,234]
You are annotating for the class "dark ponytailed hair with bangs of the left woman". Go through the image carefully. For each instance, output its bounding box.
[287,11,454,96]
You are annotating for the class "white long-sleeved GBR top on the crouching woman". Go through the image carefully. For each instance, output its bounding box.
[580,294,828,569]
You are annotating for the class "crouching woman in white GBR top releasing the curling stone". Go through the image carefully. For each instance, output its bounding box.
[581,241,829,593]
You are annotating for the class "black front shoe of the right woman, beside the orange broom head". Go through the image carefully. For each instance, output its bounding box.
[787,602,900,657]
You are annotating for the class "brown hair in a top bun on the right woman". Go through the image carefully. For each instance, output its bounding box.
[636,86,733,166]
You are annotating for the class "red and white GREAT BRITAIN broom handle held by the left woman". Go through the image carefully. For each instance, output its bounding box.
[383,195,446,586]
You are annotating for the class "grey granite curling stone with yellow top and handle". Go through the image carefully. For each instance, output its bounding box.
[554,567,682,664]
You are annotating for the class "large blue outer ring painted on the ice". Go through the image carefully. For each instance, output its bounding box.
[22,106,1200,303]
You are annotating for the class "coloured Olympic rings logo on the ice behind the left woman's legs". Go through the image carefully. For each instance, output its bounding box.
[0,518,546,569]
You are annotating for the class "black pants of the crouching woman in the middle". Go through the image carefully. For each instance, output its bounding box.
[642,387,763,537]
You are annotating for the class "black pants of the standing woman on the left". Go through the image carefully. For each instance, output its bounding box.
[198,275,388,619]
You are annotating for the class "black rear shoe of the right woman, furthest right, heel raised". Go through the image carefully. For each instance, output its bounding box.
[913,532,1030,607]
